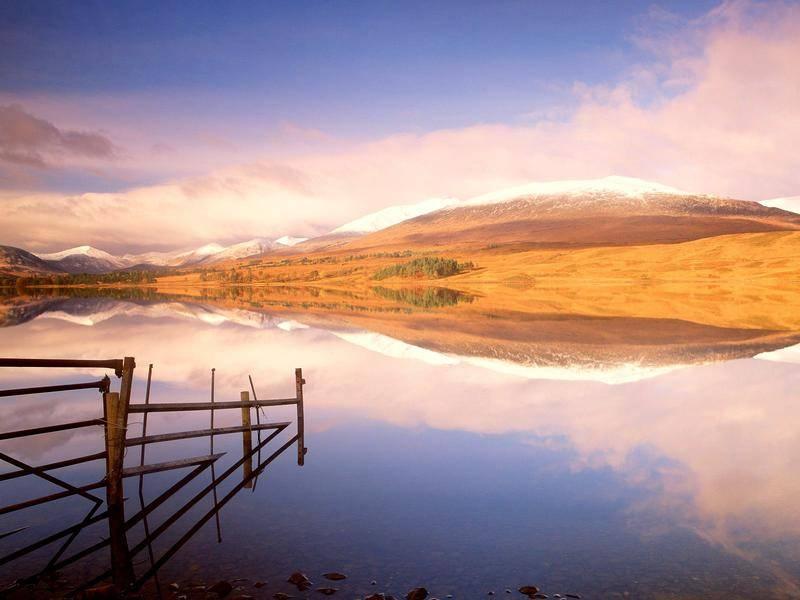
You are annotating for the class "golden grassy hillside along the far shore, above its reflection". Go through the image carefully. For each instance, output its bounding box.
[159,231,800,285]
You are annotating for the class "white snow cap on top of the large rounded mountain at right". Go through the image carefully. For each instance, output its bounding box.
[465,175,688,205]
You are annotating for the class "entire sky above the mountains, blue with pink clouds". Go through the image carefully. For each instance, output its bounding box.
[0,0,800,252]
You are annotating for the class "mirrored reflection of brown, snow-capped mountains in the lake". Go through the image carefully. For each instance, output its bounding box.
[0,287,800,384]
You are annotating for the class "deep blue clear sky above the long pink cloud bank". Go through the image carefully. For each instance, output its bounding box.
[0,0,713,136]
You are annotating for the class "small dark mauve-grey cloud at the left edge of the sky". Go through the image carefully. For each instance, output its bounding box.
[0,104,115,168]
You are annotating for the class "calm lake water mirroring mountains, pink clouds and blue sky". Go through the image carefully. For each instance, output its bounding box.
[0,293,800,598]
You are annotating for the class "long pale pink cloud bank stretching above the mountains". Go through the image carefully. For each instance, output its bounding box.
[0,2,800,250]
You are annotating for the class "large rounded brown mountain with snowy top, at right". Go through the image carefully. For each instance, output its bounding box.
[345,176,800,250]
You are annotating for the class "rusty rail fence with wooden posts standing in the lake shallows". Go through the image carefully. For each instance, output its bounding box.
[0,357,307,593]
